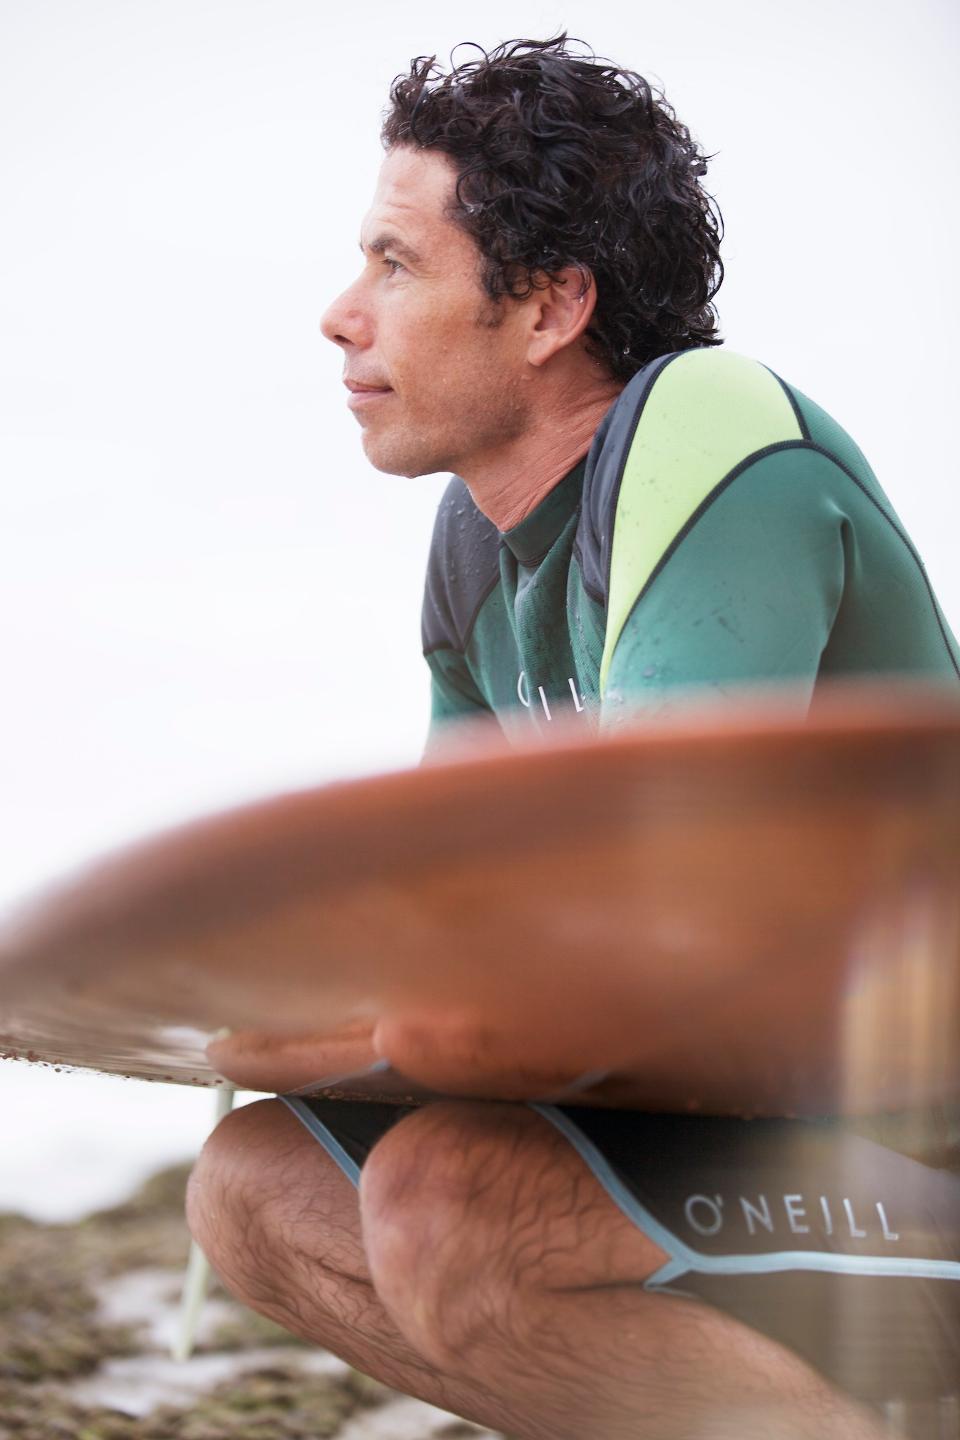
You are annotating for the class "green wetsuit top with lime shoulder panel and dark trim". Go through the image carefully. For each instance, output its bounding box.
[423,348,960,749]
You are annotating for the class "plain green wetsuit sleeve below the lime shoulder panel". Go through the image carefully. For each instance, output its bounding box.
[602,445,849,726]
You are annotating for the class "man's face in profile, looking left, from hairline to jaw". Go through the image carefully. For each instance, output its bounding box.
[321,147,530,475]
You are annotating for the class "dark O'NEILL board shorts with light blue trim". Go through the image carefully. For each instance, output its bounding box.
[281,1096,960,1440]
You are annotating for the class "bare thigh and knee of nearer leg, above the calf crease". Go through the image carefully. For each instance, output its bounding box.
[360,1100,668,1306]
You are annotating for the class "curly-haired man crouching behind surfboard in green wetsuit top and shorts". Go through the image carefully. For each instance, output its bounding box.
[189,37,960,1440]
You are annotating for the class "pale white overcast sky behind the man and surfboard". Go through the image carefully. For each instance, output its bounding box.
[0,0,960,1212]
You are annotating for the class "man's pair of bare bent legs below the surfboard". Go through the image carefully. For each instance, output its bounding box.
[189,1102,877,1440]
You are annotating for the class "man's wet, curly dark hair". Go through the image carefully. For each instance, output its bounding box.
[381,33,724,380]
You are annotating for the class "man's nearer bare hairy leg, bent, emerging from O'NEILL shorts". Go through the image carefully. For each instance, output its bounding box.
[360,1102,877,1440]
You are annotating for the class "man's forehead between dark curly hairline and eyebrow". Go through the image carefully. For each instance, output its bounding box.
[361,145,466,245]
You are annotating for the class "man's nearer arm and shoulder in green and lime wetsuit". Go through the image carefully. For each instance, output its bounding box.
[590,351,960,724]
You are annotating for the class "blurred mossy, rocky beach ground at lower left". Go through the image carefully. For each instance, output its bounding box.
[0,1165,506,1440]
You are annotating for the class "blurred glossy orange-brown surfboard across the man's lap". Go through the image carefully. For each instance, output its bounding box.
[0,684,960,1115]
